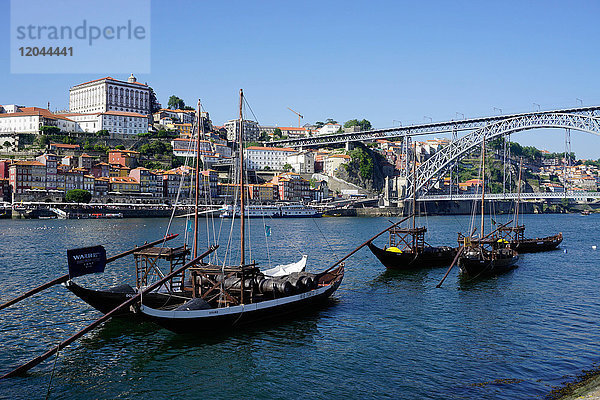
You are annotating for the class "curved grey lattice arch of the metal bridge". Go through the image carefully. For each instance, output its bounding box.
[407,113,600,196]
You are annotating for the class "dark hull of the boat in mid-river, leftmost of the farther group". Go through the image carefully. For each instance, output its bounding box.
[367,243,457,270]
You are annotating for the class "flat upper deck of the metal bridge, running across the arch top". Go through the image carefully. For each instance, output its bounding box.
[265,106,600,148]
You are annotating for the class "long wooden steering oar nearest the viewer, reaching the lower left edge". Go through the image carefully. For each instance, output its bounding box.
[0,245,219,379]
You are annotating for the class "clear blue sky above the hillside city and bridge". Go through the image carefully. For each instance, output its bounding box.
[0,0,600,159]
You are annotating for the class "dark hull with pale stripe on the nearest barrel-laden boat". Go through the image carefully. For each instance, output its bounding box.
[140,267,343,333]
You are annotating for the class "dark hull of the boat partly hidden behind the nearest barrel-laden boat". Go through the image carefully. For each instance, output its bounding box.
[65,281,189,316]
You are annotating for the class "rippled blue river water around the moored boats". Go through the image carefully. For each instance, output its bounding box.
[0,214,600,399]
